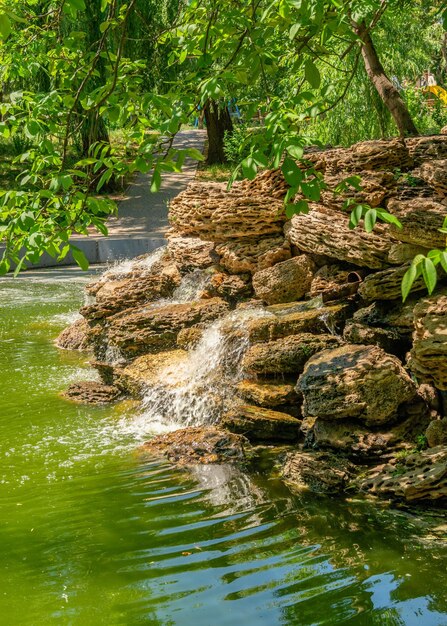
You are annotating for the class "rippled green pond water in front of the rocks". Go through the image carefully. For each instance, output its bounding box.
[0,271,447,626]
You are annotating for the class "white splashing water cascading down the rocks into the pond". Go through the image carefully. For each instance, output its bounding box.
[140,308,271,432]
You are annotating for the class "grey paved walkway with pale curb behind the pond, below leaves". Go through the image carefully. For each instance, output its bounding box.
[8,130,206,267]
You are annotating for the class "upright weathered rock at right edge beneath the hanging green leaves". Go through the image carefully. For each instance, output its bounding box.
[408,292,447,391]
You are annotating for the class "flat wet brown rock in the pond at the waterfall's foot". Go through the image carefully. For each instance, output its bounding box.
[142,427,248,465]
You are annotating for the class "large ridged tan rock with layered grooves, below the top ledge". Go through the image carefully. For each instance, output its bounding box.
[285,204,392,269]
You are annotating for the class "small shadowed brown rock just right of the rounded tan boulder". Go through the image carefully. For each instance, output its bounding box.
[310,265,364,302]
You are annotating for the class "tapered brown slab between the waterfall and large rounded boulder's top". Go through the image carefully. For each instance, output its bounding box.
[242,333,340,376]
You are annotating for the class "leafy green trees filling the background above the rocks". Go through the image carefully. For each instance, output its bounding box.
[0,0,447,272]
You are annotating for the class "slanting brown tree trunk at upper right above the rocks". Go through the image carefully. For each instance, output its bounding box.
[353,22,419,137]
